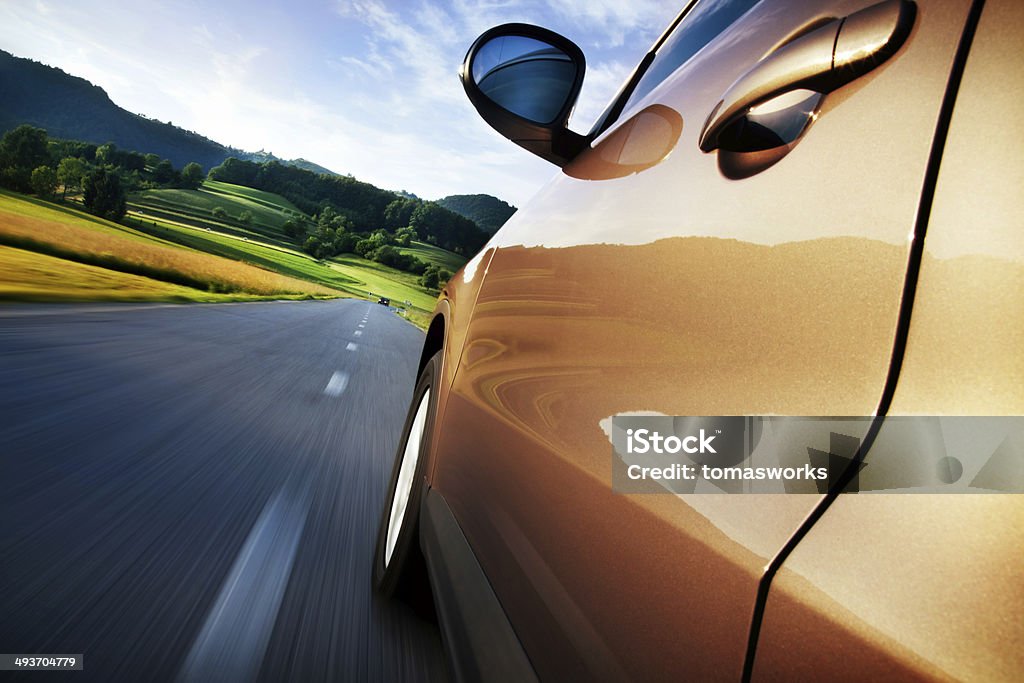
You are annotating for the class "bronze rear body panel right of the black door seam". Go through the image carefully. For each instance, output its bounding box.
[754,0,1024,681]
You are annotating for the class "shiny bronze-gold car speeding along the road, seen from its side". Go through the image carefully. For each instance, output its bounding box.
[374,0,1024,681]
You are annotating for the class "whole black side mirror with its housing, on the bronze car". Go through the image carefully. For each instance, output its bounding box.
[459,24,588,166]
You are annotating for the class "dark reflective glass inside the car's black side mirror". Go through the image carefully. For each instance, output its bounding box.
[472,36,578,124]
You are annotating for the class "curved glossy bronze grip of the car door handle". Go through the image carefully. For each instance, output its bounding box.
[699,0,915,152]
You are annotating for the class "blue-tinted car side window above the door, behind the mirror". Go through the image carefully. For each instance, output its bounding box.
[602,0,761,124]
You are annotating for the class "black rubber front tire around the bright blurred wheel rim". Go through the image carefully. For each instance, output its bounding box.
[373,351,441,605]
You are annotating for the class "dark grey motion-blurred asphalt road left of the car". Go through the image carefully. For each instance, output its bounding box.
[0,301,446,682]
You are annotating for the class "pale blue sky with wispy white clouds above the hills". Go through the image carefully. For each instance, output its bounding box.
[0,0,682,206]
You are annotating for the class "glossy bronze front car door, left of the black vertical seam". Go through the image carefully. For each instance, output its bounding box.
[432,0,968,680]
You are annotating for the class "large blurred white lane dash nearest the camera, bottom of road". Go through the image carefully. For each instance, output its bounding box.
[178,484,309,681]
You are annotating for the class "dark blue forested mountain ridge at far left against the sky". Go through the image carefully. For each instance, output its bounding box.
[0,50,331,173]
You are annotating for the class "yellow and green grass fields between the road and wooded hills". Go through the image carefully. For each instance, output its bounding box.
[0,180,466,327]
